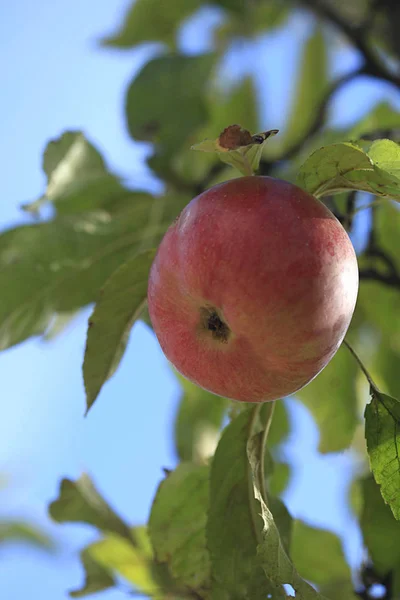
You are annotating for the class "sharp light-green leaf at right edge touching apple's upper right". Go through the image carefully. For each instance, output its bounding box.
[297,140,400,200]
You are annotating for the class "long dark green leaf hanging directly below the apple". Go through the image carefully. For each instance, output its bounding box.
[207,408,280,600]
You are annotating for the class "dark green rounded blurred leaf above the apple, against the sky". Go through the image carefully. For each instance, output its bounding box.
[126,54,215,153]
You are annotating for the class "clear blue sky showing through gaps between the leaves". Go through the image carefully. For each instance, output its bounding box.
[0,0,398,600]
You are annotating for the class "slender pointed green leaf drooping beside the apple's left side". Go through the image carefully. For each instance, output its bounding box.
[83,250,155,410]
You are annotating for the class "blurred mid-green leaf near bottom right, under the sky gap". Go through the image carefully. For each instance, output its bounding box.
[290,519,351,585]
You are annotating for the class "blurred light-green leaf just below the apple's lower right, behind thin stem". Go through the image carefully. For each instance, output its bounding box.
[296,348,358,453]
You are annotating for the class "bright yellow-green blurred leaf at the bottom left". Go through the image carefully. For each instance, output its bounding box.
[87,529,161,597]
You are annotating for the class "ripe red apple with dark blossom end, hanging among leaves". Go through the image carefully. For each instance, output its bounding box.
[148,176,358,402]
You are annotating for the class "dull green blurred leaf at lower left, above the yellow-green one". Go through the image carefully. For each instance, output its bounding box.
[49,475,132,543]
